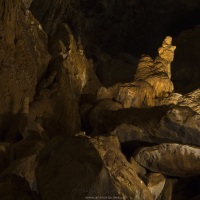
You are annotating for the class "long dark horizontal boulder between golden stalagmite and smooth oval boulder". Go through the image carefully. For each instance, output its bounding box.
[109,106,200,146]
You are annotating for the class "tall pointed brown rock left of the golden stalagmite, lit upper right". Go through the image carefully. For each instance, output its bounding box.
[30,24,89,137]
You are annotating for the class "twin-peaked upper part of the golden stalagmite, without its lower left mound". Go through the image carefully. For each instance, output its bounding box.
[135,36,176,97]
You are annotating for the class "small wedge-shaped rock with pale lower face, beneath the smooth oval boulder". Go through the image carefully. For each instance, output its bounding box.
[146,173,166,199]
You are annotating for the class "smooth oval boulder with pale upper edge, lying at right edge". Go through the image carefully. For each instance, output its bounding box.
[134,143,200,177]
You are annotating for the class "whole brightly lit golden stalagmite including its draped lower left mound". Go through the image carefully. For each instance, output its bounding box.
[102,36,176,108]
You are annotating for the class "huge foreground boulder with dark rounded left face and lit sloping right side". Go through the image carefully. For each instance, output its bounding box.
[36,136,152,200]
